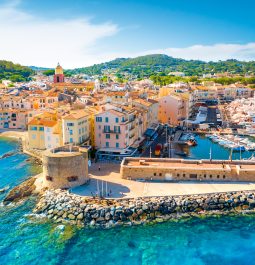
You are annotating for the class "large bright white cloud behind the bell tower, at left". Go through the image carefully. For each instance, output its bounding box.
[0,1,118,68]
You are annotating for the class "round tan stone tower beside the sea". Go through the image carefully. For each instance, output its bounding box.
[43,146,89,189]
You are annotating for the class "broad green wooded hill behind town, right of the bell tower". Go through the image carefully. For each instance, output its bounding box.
[69,54,255,77]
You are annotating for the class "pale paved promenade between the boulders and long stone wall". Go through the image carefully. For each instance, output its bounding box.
[72,163,255,198]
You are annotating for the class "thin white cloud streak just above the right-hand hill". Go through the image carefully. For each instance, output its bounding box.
[139,42,255,61]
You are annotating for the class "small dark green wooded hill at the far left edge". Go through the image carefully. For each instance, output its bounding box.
[0,60,34,82]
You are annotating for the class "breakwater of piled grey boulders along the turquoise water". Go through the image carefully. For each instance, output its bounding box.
[34,190,255,227]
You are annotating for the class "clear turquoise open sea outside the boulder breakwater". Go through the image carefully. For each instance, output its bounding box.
[0,138,255,265]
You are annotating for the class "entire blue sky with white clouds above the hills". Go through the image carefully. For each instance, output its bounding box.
[0,0,255,69]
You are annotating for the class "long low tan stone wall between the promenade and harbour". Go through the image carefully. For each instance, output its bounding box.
[120,158,255,181]
